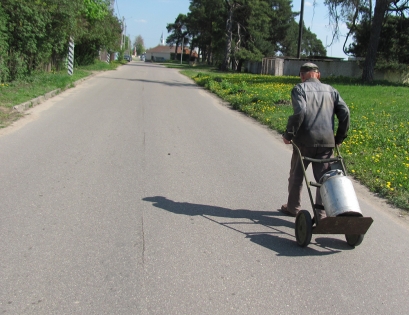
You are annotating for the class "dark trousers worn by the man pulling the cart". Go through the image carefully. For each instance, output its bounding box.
[287,147,334,218]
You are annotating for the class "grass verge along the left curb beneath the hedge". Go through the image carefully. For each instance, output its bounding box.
[0,61,121,128]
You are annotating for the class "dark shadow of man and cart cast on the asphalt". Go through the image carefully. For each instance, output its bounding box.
[142,196,350,256]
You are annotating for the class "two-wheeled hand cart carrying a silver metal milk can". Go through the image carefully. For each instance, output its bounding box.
[292,142,373,247]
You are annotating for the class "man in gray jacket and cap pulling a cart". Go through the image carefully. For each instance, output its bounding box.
[281,62,349,219]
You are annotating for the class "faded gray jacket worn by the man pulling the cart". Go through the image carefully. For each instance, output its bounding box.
[284,78,349,148]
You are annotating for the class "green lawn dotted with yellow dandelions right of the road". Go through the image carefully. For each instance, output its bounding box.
[182,68,409,210]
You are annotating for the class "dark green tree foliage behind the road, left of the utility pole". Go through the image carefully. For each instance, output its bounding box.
[167,0,326,72]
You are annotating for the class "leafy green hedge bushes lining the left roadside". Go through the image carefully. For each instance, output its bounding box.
[0,0,120,82]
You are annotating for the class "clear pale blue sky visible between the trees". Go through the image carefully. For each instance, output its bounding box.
[114,0,347,58]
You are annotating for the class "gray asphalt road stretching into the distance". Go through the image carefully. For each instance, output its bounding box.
[0,62,409,315]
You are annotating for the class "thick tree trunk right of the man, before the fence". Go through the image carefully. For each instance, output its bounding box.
[362,0,391,83]
